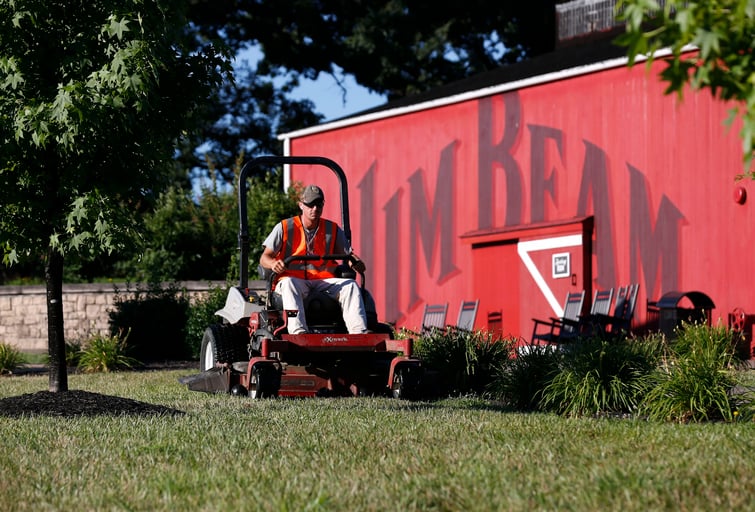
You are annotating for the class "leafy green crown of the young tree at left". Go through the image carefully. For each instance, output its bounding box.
[0,0,227,263]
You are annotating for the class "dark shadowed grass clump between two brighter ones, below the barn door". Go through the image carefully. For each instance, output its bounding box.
[490,345,563,411]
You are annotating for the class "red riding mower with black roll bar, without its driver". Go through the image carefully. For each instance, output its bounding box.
[181,156,423,398]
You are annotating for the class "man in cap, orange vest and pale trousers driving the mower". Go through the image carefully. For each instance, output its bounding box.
[260,185,367,334]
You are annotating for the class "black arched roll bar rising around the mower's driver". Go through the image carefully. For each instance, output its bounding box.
[239,156,351,289]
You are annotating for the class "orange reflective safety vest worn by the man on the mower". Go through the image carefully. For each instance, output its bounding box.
[278,216,338,279]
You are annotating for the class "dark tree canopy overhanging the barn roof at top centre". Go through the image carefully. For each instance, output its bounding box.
[197,0,557,99]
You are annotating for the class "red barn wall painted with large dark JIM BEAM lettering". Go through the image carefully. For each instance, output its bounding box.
[283,57,755,339]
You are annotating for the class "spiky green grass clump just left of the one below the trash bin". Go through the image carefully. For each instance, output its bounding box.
[542,338,659,416]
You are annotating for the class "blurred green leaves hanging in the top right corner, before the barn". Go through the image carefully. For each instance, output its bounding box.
[618,0,755,175]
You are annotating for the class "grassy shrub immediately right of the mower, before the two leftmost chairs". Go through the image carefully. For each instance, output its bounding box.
[414,329,511,395]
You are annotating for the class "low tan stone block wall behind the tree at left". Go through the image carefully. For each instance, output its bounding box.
[0,281,226,352]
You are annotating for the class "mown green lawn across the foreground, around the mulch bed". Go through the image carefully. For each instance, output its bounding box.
[0,370,755,512]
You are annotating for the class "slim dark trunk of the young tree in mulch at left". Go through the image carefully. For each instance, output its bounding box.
[45,247,68,393]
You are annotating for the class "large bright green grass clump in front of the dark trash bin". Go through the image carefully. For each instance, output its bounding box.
[641,324,736,423]
